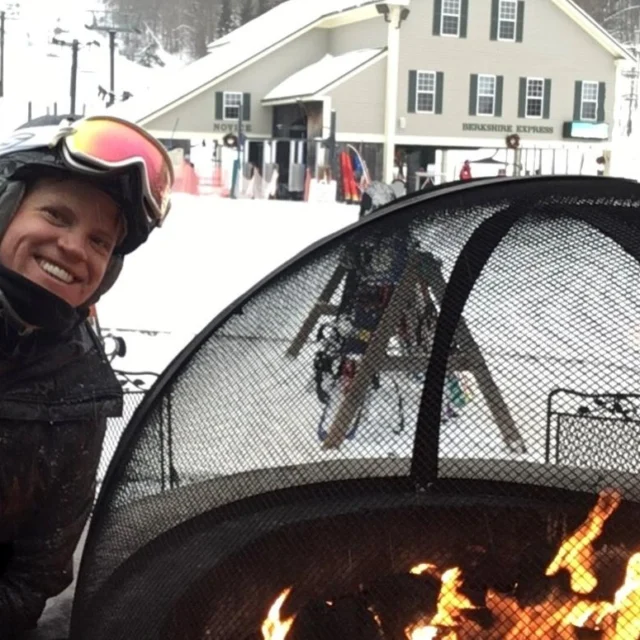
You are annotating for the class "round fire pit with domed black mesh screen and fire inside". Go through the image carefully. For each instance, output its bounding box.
[72,177,640,640]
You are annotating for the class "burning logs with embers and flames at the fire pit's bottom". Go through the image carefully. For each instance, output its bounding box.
[261,489,640,640]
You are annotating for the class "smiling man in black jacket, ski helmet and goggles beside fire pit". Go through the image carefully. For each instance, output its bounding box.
[0,117,173,640]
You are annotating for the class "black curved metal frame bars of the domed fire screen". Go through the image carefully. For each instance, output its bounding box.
[72,176,640,637]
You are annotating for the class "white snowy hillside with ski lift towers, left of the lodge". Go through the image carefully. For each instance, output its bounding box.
[0,0,183,136]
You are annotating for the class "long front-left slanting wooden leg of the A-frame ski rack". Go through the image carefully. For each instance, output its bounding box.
[324,254,419,449]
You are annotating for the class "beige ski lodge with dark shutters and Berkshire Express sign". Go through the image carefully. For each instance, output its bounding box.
[112,0,637,192]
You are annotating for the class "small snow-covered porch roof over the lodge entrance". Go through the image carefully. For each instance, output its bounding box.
[263,49,385,102]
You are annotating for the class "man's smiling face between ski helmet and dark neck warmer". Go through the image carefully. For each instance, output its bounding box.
[0,178,122,307]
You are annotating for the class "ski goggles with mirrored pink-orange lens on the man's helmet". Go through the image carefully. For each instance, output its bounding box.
[52,116,174,228]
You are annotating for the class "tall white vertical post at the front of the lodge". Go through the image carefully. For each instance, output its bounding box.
[383,6,401,184]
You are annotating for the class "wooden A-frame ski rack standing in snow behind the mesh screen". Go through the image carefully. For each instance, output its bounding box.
[287,250,521,453]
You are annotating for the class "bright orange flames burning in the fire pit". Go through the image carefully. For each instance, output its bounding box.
[262,489,640,640]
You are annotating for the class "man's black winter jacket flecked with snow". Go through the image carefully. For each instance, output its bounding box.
[0,323,122,639]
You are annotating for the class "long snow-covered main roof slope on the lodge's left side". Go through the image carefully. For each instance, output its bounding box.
[110,0,379,122]
